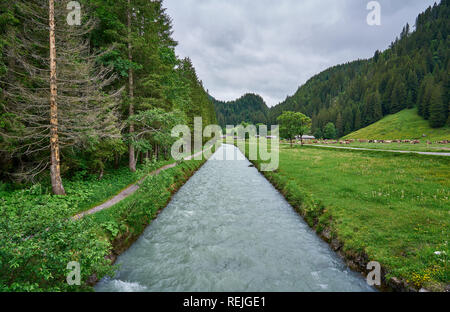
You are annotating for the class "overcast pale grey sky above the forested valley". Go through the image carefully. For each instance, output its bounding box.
[165,0,435,106]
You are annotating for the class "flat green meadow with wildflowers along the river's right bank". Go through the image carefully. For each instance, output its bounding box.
[241,145,450,290]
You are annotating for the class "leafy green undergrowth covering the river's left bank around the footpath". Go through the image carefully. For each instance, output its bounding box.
[0,160,204,291]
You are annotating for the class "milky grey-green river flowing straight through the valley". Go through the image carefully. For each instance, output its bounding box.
[95,145,374,292]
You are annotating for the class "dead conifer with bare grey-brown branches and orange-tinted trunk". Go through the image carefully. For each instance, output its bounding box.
[0,0,122,195]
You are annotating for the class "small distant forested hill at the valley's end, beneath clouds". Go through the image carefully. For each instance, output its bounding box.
[211,94,269,128]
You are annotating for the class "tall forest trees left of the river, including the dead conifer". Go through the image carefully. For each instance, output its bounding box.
[0,0,216,194]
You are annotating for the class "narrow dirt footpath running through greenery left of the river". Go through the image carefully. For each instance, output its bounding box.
[72,146,212,220]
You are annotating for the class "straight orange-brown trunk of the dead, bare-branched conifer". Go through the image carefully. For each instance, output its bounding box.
[49,0,66,195]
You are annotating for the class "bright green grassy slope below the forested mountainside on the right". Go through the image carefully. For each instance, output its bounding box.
[344,109,450,141]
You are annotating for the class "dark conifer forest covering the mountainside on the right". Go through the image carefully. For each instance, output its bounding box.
[269,0,450,137]
